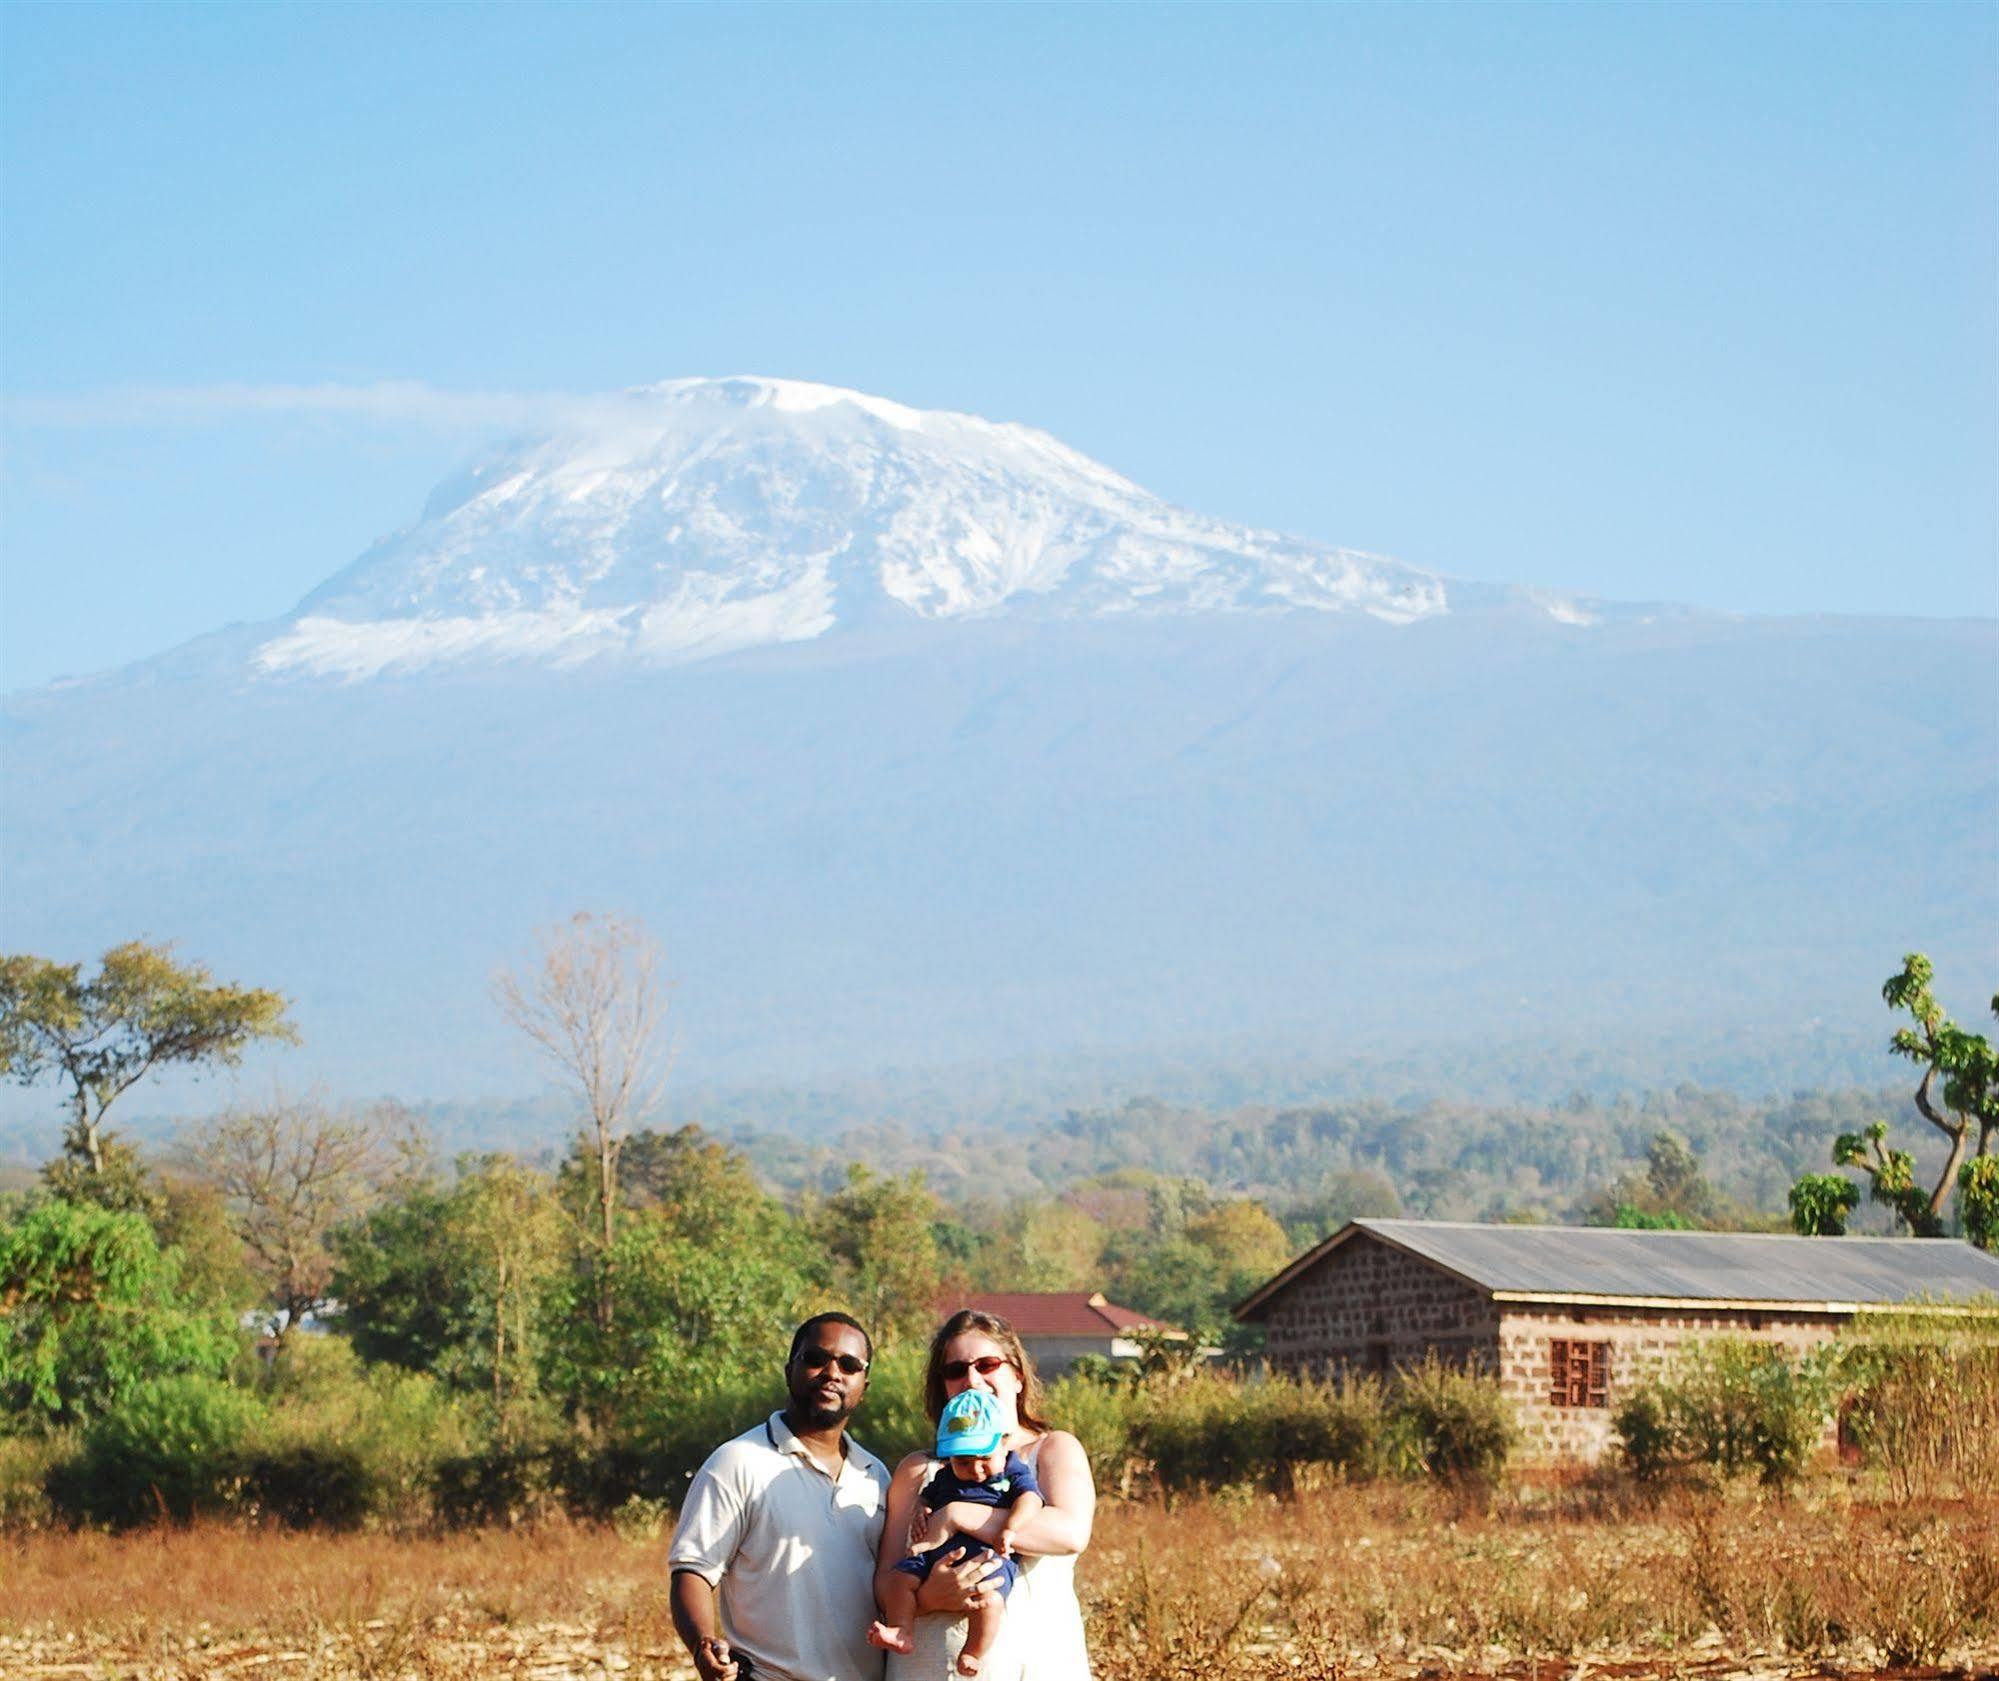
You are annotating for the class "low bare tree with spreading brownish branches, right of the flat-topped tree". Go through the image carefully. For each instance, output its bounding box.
[186,1095,406,1355]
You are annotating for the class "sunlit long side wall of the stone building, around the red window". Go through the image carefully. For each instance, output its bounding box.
[1499,1305,1845,1463]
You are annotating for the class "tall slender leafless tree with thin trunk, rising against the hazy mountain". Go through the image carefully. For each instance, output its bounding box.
[494,911,670,1329]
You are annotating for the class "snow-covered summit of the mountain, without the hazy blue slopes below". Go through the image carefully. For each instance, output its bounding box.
[254,378,1597,678]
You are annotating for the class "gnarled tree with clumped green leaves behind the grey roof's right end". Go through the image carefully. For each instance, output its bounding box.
[1791,951,1999,1249]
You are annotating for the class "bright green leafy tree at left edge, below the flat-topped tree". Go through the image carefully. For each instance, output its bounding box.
[0,1201,244,1427]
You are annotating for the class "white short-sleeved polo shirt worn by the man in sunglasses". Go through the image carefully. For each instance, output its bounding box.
[668,1413,888,1681]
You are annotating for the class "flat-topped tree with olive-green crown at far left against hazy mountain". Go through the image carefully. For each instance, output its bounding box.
[0,939,296,1173]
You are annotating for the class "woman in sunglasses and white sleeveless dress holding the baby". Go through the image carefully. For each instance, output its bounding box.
[876,1307,1097,1681]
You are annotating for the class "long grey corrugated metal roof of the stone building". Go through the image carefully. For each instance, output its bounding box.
[1353,1219,1999,1305]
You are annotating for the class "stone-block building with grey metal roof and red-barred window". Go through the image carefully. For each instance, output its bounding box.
[1235,1219,1999,1459]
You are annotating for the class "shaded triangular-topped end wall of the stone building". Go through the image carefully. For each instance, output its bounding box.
[1263,1231,1499,1375]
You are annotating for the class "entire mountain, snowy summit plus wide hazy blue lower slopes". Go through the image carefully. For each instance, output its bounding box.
[0,380,1999,1095]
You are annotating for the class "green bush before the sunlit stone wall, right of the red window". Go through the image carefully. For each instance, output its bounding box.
[1611,1337,1839,1487]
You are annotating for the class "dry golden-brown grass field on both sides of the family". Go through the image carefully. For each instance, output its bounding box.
[0,1485,1999,1681]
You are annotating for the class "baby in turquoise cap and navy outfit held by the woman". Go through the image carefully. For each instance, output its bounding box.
[868,1389,1043,1675]
